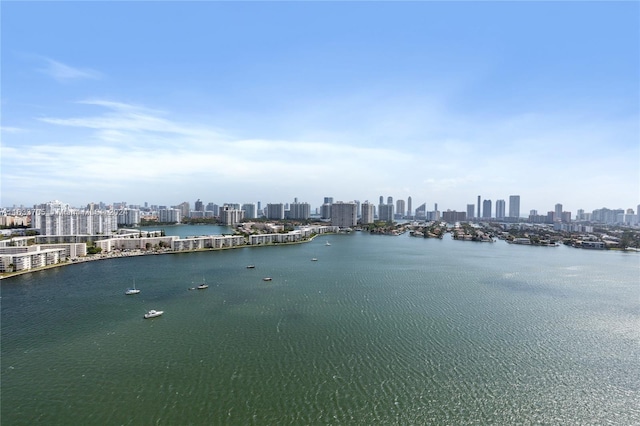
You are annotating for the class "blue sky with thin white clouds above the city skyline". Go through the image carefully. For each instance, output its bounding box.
[0,1,640,216]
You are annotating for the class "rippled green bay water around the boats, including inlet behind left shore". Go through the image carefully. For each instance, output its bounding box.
[1,231,640,425]
